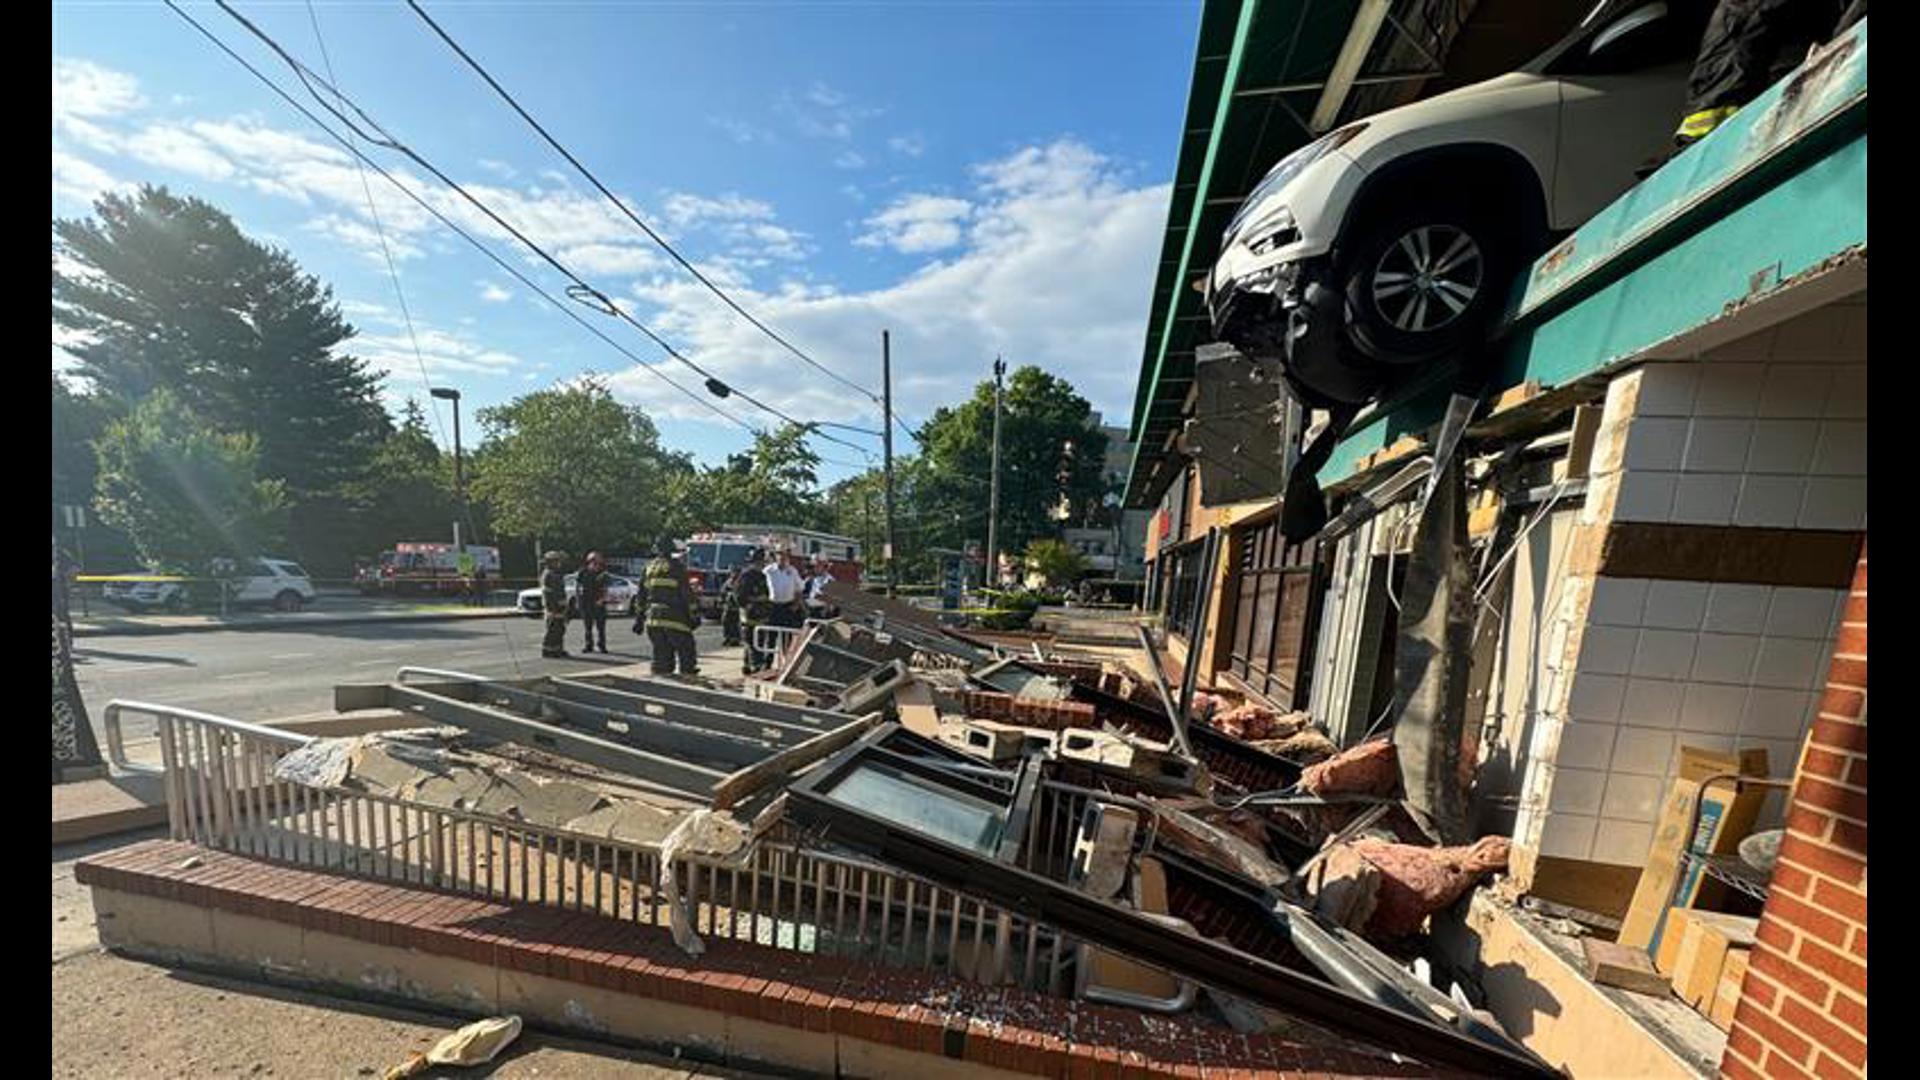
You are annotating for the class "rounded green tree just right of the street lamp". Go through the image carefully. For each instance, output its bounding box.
[468,377,691,553]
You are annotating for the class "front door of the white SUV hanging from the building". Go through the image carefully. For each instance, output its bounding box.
[1548,0,1707,229]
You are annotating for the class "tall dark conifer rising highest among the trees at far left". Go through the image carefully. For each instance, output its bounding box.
[54,186,392,565]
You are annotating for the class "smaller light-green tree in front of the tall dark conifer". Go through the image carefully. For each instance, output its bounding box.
[96,388,286,573]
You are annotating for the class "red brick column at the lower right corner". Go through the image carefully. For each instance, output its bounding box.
[1720,544,1866,1080]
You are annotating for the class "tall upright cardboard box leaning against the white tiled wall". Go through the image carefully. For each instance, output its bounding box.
[1619,746,1766,945]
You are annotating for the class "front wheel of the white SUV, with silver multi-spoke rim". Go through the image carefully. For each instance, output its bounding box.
[1340,204,1517,363]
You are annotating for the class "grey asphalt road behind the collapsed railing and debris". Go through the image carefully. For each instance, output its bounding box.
[73,619,720,759]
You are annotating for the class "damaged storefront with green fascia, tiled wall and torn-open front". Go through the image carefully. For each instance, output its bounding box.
[1127,10,1866,1076]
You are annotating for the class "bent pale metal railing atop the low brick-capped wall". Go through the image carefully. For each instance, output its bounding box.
[131,691,1077,994]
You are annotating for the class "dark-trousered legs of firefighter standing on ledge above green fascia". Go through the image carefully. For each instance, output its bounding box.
[1674,0,1866,148]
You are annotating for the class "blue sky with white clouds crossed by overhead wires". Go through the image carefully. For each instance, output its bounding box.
[52,2,1198,479]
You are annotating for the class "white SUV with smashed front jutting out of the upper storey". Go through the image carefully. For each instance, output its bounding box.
[1206,0,1711,405]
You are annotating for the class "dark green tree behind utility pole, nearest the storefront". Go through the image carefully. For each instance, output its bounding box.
[920,365,1106,552]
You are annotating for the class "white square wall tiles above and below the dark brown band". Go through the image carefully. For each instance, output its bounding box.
[1517,304,1866,865]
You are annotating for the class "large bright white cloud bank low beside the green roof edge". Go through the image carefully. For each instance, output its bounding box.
[611,142,1169,430]
